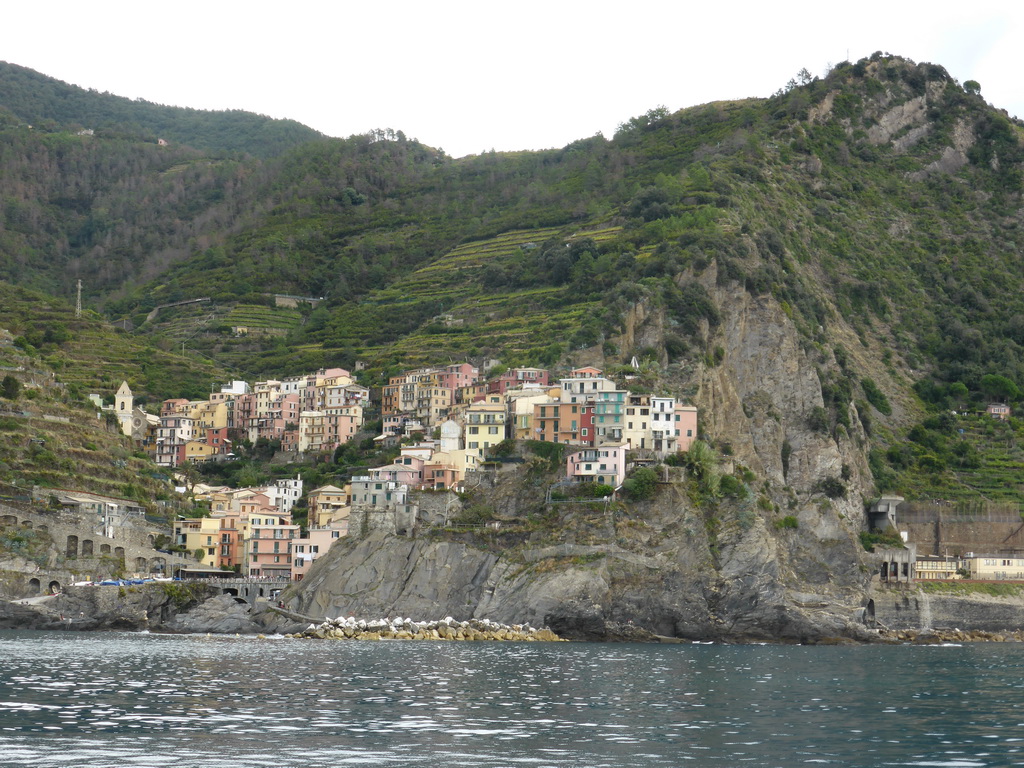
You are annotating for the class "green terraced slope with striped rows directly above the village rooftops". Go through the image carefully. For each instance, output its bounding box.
[234,227,621,376]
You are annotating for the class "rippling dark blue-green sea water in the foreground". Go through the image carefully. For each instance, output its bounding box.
[0,632,1024,768]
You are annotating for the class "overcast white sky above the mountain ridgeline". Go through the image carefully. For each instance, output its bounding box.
[0,0,1024,157]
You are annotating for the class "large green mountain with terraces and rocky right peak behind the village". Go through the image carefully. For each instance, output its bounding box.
[0,54,1024,507]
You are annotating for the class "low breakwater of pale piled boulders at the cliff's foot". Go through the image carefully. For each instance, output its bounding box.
[286,616,562,643]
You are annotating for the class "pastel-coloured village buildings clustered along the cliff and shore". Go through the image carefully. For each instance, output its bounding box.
[25,361,1024,585]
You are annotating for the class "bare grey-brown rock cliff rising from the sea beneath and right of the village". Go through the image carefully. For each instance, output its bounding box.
[286,269,921,642]
